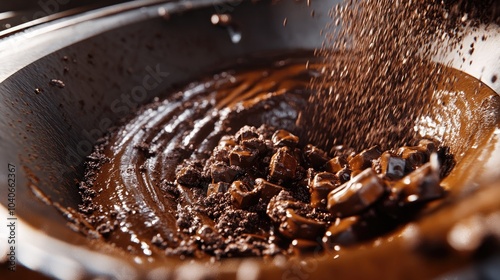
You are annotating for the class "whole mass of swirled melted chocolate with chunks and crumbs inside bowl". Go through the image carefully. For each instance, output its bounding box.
[75,54,464,258]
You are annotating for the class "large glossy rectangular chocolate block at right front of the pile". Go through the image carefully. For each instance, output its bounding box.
[327,168,385,217]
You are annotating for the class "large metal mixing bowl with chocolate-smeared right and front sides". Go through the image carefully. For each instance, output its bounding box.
[0,0,500,279]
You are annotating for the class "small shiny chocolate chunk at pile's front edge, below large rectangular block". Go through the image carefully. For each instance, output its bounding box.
[324,216,360,245]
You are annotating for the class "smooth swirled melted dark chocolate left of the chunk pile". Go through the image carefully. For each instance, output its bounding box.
[76,54,493,264]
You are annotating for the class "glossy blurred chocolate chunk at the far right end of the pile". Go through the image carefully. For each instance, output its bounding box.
[391,153,444,205]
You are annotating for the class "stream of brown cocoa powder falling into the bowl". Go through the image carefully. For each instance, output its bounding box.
[299,0,495,152]
